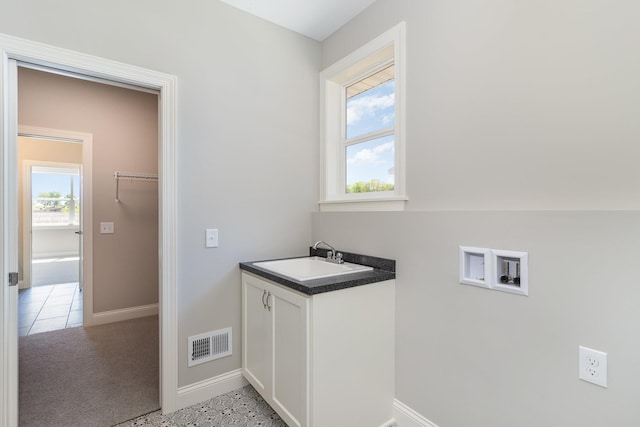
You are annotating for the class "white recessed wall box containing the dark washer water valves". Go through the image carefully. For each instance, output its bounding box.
[491,249,529,295]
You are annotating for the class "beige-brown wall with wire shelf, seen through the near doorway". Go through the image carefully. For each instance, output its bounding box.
[18,68,158,313]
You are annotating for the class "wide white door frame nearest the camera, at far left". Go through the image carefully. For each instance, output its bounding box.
[0,34,178,427]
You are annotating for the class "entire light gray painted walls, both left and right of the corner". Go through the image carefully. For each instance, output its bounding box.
[6,0,640,427]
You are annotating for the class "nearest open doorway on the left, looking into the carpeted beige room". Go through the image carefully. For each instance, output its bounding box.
[18,66,165,425]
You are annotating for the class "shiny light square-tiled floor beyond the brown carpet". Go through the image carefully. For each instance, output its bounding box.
[18,282,82,336]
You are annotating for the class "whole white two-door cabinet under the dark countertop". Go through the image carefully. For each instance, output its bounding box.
[242,271,395,427]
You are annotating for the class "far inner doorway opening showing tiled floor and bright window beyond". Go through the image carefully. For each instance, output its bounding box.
[18,158,83,336]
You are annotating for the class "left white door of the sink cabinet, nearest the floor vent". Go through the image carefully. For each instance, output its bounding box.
[242,274,271,398]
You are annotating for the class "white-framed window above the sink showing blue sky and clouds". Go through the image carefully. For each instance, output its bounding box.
[320,23,406,211]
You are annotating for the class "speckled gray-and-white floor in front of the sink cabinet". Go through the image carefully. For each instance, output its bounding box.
[117,385,287,427]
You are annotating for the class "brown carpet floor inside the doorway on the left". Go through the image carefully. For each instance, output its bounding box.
[18,316,160,427]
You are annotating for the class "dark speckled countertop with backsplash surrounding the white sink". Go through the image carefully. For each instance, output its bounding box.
[240,248,396,295]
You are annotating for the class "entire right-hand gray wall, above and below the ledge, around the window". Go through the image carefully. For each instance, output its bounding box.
[313,0,640,427]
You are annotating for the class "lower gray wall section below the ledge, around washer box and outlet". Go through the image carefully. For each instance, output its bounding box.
[314,211,640,427]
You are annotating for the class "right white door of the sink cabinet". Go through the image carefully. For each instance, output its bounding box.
[269,286,310,427]
